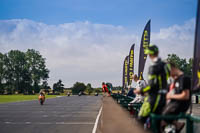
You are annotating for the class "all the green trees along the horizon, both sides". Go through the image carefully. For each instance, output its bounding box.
[0,49,192,94]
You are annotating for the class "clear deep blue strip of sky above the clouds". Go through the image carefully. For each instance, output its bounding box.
[0,0,197,31]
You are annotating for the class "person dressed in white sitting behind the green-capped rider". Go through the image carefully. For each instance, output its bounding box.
[130,74,147,104]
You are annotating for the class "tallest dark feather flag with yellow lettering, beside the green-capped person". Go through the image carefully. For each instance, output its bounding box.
[138,20,151,79]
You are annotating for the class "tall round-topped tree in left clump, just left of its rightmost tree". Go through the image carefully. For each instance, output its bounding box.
[4,50,30,93]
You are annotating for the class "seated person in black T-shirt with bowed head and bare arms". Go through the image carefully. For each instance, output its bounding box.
[161,63,191,132]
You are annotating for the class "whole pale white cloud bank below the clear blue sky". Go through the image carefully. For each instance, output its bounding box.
[0,19,194,87]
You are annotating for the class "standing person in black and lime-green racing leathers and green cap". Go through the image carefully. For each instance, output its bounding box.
[135,45,170,123]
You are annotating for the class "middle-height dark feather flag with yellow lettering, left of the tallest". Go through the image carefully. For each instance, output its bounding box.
[128,44,135,85]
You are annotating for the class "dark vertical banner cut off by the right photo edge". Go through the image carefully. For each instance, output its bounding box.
[192,0,200,92]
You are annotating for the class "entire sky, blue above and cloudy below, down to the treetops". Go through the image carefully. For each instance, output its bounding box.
[0,0,197,87]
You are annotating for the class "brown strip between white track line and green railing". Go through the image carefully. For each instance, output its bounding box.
[97,97,147,133]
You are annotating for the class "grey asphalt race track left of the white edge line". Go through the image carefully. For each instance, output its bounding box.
[0,96,102,133]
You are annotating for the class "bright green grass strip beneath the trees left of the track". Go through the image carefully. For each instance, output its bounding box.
[0,95,58,103]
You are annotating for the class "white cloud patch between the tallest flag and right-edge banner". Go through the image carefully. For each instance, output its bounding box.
[151,19,195,58]
